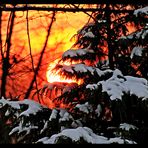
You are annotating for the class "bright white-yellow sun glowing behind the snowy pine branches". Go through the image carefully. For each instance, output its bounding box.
[46,59,83,85]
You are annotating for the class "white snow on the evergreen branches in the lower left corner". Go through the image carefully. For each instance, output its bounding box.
[0,97,45,135]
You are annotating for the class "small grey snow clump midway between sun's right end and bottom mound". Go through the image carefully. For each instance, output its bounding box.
[75,102,93,114]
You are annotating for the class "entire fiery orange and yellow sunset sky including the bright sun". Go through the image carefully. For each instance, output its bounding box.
[0,4,139,107]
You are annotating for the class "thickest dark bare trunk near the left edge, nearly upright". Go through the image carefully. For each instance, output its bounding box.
[1,11,15,97]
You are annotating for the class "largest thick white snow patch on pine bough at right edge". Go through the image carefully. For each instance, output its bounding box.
[86,69,148,100]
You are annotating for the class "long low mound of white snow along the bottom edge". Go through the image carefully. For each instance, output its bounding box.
[37,127,135,144]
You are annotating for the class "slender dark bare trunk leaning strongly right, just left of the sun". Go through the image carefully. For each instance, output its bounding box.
[25,12,56,99]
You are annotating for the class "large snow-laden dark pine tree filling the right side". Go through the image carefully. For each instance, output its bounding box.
[43,4,148,141]
